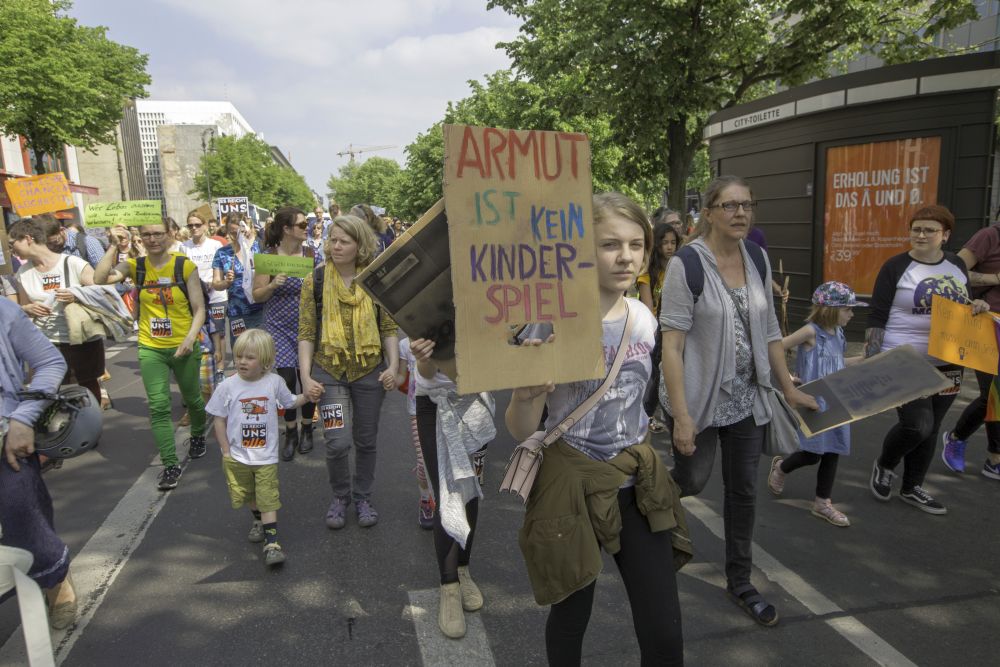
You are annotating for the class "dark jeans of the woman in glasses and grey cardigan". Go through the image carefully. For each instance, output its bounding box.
[669,415,766,589]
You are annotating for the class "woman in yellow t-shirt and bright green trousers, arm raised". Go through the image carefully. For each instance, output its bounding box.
[94,221,205,491]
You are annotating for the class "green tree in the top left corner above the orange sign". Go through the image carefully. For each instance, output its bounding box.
[0,0,150,173]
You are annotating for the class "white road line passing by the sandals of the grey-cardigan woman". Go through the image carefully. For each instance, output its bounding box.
[684,497,916,667]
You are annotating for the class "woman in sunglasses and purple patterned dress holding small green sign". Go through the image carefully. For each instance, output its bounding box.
[253,206,319,461]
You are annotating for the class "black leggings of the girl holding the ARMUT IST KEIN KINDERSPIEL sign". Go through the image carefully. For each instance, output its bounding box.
[545,487,684,666]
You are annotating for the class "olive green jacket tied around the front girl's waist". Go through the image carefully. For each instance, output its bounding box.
[518,440,694,605]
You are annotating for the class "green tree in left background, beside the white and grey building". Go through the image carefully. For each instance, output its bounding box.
[192,134,316,211]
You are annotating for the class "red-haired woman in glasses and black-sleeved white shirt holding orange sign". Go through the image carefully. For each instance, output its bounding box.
[865,206,990,514]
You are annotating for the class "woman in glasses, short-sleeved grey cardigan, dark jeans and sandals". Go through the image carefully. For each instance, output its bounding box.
[660,176,818,626]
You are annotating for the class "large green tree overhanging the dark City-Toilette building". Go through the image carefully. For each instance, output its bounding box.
[488,0,977,208]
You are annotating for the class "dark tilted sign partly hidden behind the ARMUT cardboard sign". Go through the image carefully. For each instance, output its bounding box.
[355,199,455,361]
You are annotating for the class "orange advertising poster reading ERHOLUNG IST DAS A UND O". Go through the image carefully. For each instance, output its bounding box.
[823,137,941,294]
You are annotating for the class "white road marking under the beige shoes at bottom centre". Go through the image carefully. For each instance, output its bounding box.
[403,588,496,667]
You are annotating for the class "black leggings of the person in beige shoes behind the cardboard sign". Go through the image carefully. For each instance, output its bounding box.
[417,396,479,584]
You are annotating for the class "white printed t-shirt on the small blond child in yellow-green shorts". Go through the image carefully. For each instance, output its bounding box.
[205,373,296,466]
